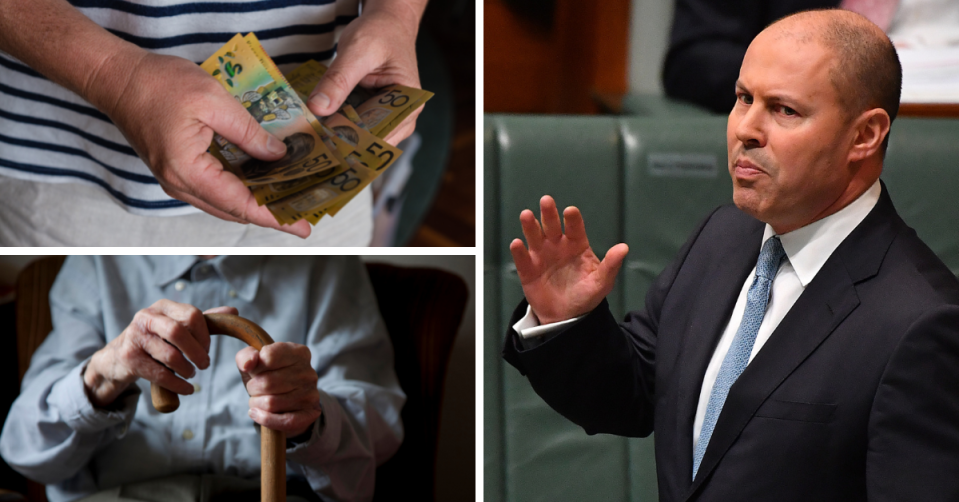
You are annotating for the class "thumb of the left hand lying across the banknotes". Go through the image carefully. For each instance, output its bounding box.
[206,99,286,160]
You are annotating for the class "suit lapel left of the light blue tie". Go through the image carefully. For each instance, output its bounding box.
[676,222,765,486]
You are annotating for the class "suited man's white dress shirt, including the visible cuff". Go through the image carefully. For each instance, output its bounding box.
[513,180,882,449]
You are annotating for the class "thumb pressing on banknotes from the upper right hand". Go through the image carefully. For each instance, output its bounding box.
[307,44,382,117]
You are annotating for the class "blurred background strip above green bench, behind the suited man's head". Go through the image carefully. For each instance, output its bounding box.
[483,0,959,117]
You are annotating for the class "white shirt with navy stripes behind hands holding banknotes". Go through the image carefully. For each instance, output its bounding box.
[0,0,359,216]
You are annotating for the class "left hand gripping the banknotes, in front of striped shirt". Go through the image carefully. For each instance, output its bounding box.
[106,52,310,237]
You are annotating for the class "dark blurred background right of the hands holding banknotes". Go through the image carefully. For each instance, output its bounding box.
[372,0,476,247]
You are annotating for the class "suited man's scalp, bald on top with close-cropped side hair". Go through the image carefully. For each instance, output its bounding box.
[756,9,902,126]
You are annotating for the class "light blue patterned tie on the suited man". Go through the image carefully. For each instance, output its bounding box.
[693,237,786,479]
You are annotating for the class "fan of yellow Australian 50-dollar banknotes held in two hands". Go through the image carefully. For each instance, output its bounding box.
[201,33,433,225]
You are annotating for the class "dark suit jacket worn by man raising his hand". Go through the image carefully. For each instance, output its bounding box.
[504,186,959,502]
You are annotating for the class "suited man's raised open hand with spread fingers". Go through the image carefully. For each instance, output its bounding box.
[509,195,629,324]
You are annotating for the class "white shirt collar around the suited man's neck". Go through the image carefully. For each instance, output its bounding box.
[762,180,882,288]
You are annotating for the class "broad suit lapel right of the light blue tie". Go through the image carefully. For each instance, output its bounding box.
[683,179,903,500]
